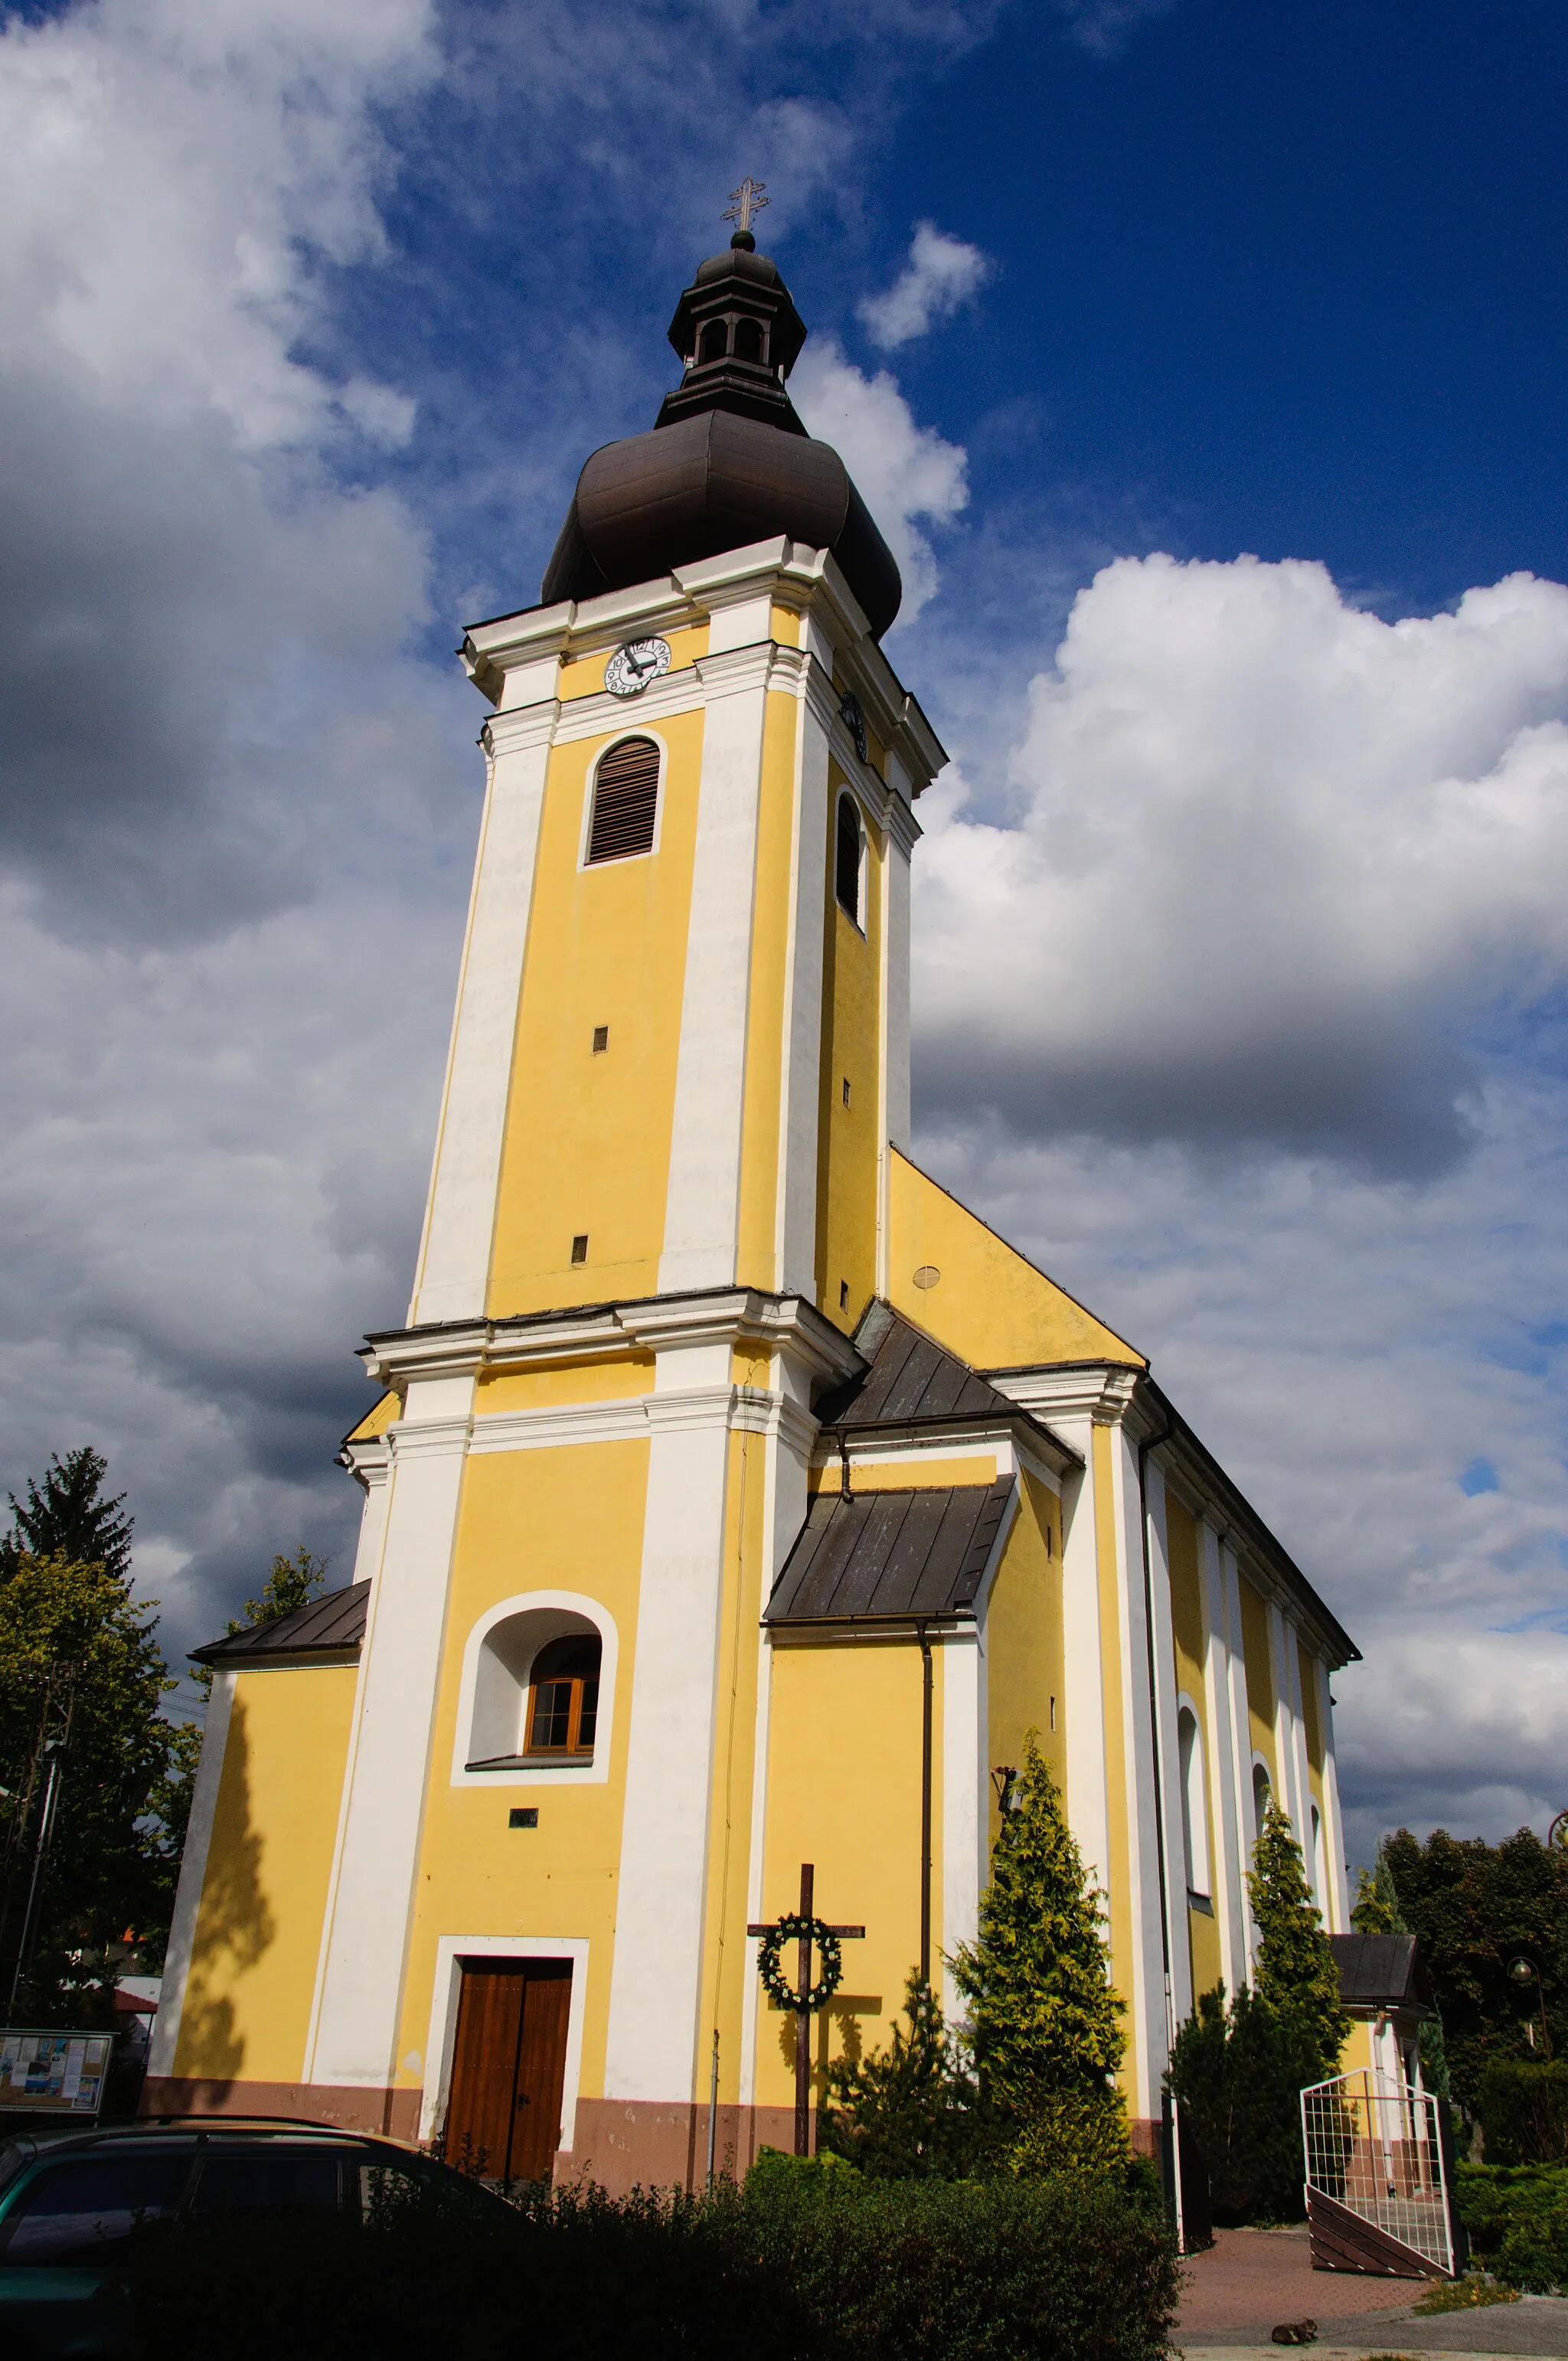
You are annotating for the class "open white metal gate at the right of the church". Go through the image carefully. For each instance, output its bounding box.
[1301,2066,1455,2276]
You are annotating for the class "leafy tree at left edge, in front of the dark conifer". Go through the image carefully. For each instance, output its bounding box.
[0,1551,177,2021]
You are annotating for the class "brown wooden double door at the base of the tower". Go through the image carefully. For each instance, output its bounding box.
[446,1960,571,2182]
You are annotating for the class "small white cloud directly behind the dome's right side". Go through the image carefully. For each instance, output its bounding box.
[789,335,969,623]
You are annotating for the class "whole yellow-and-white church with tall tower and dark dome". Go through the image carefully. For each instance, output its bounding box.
[144,212,1355,2189]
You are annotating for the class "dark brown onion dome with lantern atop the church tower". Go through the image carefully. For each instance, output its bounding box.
[538,229,904,640]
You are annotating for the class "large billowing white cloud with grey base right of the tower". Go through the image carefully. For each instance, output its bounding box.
[919,557,1568,1171]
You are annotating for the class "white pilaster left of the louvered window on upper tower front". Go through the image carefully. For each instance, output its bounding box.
[409,699,560,1327]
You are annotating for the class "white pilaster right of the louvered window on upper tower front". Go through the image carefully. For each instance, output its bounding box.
[659,645,773,1294]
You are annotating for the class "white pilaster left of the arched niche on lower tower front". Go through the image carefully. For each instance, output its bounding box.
[305,1370,475,2087]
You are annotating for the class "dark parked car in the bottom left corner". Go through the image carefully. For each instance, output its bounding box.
[0,2115,503,2361]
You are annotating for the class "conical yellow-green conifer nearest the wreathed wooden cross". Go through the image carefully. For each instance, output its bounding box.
[952,1731,1126,2165]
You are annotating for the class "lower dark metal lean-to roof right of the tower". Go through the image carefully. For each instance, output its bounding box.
[763,1476,1013,1627]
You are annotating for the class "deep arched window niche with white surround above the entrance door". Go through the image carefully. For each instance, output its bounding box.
[453,1592,614,1785]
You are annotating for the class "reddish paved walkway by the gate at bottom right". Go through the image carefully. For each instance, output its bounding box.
[1171,2226,1568,2361]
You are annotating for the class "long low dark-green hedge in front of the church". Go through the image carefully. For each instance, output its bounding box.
[135,2158,1176,2361]
